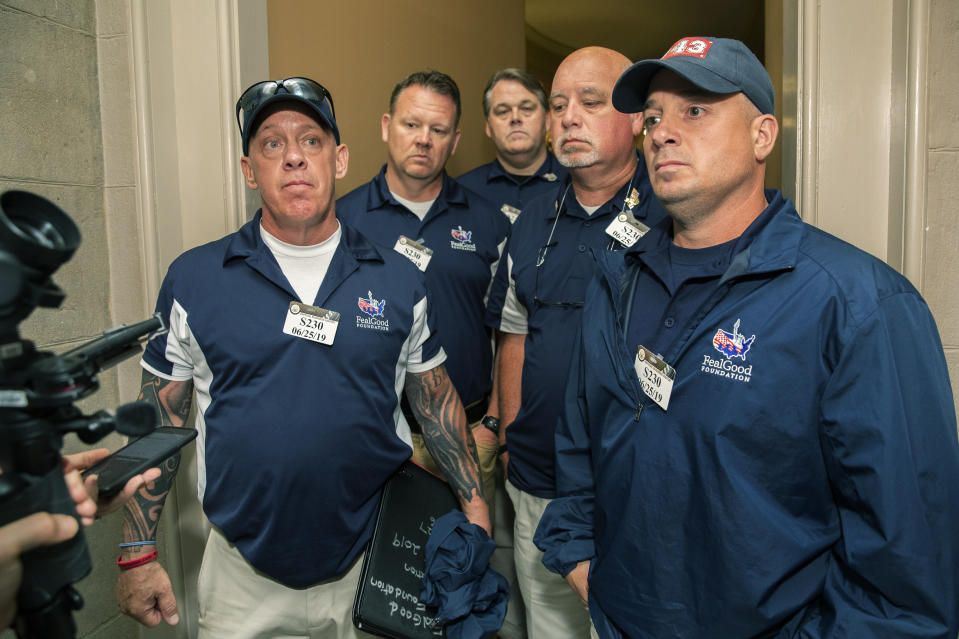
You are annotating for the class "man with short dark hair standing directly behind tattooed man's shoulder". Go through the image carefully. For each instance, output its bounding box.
[336,71,509,520]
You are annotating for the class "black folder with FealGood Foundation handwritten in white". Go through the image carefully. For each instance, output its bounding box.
[353,461,459,639]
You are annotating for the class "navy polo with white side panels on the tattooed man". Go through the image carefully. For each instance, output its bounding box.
[142,213,444,588]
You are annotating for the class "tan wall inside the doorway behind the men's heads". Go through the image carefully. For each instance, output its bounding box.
[267,0,526,195]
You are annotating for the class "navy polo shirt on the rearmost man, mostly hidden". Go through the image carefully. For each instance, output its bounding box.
[456,153,566,222]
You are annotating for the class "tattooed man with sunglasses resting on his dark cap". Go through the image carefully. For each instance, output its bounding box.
[117,78,489,639]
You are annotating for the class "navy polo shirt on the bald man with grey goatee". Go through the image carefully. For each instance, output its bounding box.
[487,155,666,499]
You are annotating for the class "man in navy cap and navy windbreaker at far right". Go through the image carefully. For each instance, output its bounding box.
[536,37,959,639]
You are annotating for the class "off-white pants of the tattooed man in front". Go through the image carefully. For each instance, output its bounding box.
[197,527,373,639]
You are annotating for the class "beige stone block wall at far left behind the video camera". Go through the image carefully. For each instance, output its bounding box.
[0,0,148,639]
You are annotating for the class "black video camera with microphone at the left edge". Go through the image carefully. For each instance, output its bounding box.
[0,191,166,639]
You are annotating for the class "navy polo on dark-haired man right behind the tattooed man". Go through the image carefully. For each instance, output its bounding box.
[336,165,510,405]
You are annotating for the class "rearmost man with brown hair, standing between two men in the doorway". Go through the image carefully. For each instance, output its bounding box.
[456,68,566,222]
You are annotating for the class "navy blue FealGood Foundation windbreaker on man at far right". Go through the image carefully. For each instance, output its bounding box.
[535,191,959,639]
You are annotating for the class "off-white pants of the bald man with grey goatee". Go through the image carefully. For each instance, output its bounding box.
[506,481,591,639]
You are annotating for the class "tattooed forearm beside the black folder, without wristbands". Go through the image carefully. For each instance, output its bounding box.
[406,365,490,532]
